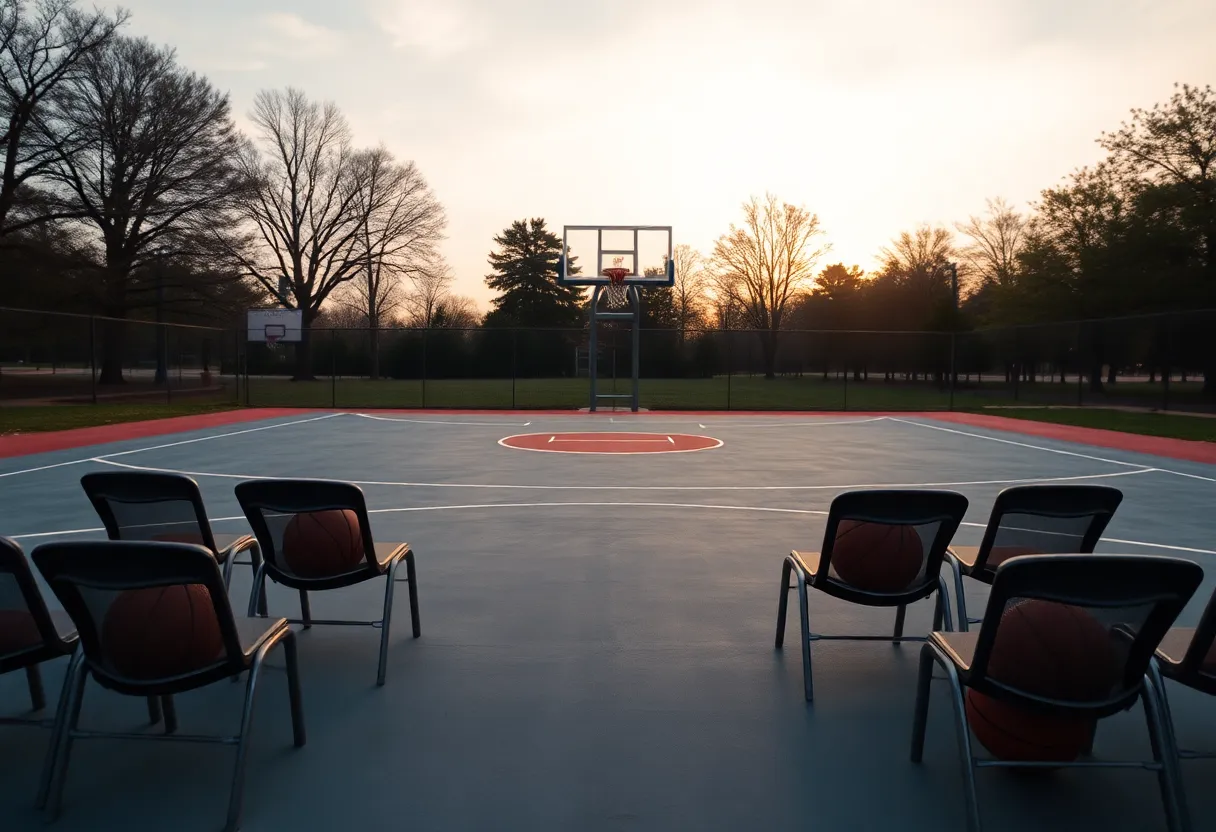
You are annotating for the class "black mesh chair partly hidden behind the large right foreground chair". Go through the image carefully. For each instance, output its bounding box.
[946,485,1124,633]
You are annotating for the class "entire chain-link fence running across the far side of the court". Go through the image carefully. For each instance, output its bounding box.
[0,309,1216,412]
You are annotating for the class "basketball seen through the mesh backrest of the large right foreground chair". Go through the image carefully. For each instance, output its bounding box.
[987,600,1121,702]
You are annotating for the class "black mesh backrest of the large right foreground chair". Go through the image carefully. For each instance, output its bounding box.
[967,555,1204,716]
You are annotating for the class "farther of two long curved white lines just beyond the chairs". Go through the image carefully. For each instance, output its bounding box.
[95,457,1156,491]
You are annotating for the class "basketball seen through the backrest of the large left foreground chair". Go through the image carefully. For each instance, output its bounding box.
[101,584,224,679]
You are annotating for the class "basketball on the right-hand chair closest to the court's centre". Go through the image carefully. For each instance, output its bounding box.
[831,519,924,592]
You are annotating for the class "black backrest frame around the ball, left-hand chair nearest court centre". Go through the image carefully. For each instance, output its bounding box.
[236,479,378,580]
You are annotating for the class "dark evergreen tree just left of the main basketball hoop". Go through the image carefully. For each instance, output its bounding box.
[485,219,584,327]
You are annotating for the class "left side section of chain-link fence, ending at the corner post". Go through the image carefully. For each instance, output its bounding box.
[0,308,243,405]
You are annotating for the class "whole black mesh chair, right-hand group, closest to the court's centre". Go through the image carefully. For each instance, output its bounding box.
[776,490,967,702]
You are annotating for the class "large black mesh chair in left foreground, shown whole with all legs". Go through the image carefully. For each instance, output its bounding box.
[33,541,305,832]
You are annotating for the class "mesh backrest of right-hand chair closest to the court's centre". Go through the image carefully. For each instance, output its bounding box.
[816,489,968,595]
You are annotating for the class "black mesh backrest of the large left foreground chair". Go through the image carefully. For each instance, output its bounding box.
[32,540,243,691]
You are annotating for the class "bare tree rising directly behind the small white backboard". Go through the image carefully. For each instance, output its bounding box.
[233,88,367,380]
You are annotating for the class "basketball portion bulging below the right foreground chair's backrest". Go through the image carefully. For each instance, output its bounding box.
[967,691,1093,763]
